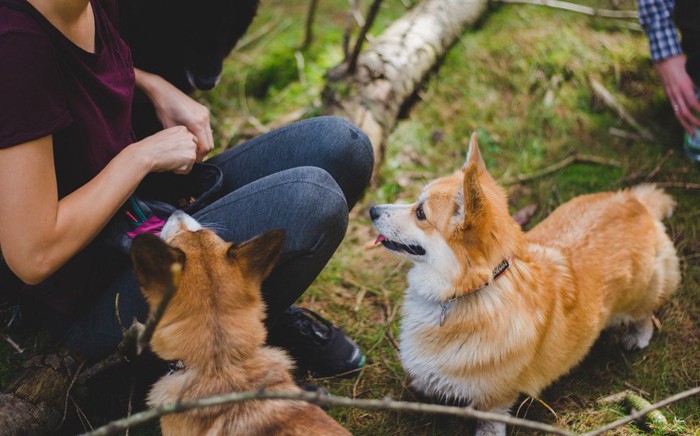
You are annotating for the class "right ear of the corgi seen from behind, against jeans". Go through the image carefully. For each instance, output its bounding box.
[228,229,284,281]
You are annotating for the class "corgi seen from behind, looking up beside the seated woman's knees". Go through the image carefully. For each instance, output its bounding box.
[132,211,350,435]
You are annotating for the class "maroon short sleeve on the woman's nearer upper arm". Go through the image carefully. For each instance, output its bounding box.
[0,18,72,148]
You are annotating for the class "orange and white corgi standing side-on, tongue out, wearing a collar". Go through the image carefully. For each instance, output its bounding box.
[370,134,680,436]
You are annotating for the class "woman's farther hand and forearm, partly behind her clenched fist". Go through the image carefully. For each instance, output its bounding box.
[135,69,214,162]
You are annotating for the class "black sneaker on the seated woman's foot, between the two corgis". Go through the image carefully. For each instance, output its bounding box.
[268,306,366,377]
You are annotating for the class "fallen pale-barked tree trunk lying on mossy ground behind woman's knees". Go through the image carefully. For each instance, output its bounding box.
[324,0,488,169]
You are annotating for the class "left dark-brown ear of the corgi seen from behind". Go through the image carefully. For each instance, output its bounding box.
[131,233,185,300]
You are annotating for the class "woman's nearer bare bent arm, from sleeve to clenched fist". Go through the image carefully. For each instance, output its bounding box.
[0,127,196,284]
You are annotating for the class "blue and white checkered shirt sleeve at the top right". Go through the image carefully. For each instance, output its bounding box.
[637,0,682,62]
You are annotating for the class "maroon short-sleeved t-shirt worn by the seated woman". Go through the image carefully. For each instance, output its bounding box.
[0,0,134,311]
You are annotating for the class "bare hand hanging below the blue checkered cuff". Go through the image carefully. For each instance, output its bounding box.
[655,55,700,135]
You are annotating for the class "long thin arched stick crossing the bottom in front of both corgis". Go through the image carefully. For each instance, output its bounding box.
[80,390,576,436]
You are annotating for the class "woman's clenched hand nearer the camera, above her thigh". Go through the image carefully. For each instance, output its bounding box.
[133,126,198,174]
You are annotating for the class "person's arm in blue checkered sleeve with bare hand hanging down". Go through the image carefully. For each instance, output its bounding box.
[637,0,700,134]
